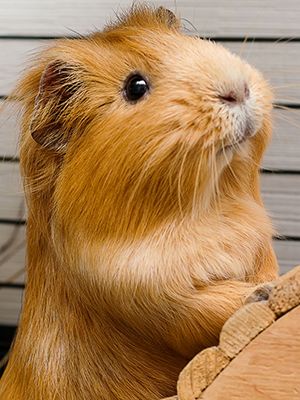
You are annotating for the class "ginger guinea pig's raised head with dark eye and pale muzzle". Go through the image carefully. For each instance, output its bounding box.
[18,8,272,260]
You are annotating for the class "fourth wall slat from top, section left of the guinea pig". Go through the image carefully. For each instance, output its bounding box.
[0,162,25,220]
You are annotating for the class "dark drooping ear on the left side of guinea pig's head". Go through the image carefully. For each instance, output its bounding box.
[30,61,79,153]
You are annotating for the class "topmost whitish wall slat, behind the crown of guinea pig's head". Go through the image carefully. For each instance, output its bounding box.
[0,0,300,37]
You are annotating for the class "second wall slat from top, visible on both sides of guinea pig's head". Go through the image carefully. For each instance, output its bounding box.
[0,39,300,102]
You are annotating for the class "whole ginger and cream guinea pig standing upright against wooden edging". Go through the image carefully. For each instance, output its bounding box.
[0,6,277,400]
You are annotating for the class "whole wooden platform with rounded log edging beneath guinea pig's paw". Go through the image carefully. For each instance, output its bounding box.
[165,266,300,400]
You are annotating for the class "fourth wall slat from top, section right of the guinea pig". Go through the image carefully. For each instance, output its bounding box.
[261,174,300,237]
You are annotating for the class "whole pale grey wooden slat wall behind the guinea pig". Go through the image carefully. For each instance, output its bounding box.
[0,0,300,376]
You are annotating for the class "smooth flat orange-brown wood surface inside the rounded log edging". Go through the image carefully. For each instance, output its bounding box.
[200,306,300,400]
